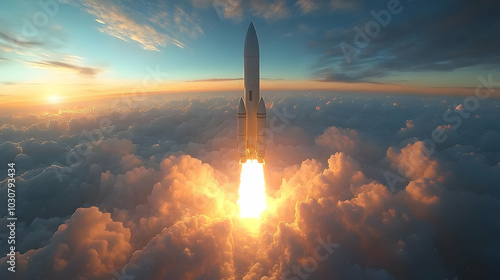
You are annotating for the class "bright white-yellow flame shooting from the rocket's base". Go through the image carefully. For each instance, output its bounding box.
[238,160,266,218]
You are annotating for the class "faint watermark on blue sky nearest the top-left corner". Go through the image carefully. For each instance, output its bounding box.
[21,0,59,38]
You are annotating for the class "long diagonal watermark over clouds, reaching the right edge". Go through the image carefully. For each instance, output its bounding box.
[384,74,500,192]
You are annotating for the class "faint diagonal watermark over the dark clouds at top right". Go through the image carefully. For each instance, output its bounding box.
[339,0,413,64]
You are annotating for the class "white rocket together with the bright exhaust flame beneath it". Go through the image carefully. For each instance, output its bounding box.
[237,23,266,218]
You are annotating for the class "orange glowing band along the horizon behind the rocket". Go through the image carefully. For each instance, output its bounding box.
[0,79,500,106]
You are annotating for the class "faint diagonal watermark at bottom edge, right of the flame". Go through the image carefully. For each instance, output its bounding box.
[283,235,340,280]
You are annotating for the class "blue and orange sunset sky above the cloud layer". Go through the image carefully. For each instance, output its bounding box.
[0,0,500,104]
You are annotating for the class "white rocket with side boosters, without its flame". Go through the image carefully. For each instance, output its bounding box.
[237,23,266,163]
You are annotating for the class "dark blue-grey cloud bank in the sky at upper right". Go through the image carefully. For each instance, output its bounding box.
[309,0,500,82]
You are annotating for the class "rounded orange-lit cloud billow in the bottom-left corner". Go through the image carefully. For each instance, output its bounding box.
[6,207,131,279]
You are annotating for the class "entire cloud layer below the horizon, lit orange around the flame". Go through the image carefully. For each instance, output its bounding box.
[0,93,500,280]
